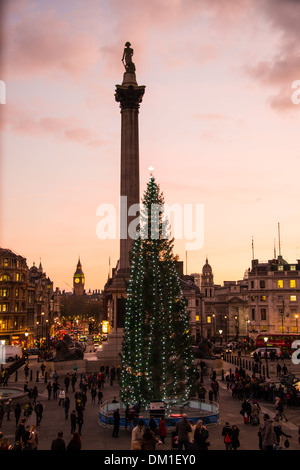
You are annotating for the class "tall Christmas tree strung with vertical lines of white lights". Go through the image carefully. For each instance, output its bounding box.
[121,176,193,405]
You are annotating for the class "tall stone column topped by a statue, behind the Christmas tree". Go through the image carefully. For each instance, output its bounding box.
[97,42,145,365]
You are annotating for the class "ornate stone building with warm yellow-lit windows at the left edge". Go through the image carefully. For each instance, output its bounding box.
[0,248,58,345]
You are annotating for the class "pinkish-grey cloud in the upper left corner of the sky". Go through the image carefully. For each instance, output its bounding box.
[3,7,99,78]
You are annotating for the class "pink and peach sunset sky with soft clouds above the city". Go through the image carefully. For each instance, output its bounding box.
[0,0,300,290]
